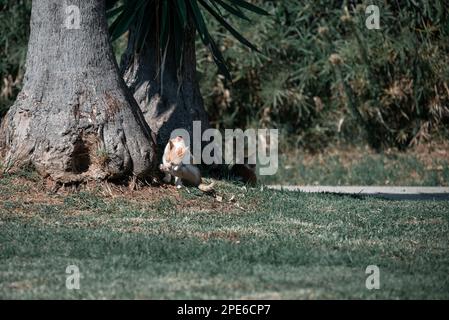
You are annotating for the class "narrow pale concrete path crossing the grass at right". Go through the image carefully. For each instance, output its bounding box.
[267,185,449,200]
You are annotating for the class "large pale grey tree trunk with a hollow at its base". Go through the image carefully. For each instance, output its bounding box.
[0,0,155,182]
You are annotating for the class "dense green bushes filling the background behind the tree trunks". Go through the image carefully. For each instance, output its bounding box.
[0,0,449,150]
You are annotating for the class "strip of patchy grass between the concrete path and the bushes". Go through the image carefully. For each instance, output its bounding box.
[262,143,449,186]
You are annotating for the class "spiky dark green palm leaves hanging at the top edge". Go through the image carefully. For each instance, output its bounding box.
[106,0,268,79]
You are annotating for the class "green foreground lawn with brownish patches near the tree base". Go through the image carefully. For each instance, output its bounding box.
[0,172,449,299]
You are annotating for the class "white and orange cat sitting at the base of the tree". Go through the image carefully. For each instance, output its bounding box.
[159,137,214,192]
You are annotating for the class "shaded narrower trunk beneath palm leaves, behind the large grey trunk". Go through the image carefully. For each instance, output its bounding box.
[121,16,209,154]
